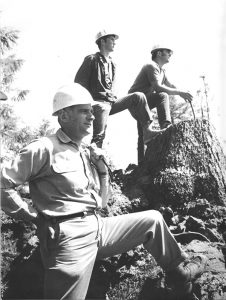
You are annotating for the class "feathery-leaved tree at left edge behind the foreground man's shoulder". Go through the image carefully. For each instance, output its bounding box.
[0,27,51,160]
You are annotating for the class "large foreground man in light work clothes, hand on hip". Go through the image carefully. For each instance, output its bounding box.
[1,84,206,300]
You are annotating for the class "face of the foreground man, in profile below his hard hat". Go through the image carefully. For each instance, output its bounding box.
[67,104,95,138]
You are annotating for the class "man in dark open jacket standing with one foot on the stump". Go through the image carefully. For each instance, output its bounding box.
[74,30,161,148]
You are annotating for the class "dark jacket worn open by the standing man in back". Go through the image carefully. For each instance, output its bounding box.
[74,52,116,102]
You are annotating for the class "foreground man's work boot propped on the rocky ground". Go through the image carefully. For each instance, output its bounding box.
[166,255,207,297]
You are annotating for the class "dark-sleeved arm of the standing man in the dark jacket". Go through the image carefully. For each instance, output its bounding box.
[74,55,92,91]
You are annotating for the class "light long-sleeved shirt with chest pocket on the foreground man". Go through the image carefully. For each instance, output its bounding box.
[1,129,102,219]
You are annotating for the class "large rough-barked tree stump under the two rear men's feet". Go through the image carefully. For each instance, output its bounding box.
[139,120,226,207]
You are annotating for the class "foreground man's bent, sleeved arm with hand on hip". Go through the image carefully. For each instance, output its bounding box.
[1,142,48,221]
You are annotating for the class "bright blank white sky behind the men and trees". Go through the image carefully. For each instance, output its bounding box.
[0,0,226,168]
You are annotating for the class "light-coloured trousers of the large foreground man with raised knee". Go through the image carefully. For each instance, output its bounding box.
[40,210,186,300]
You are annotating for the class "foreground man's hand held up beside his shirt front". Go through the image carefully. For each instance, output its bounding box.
[89,143,108,173]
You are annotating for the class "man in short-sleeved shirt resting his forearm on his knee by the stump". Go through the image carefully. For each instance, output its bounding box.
[129,45,193,159]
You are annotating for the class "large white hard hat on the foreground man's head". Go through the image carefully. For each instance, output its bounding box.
[52,83,95,116]
